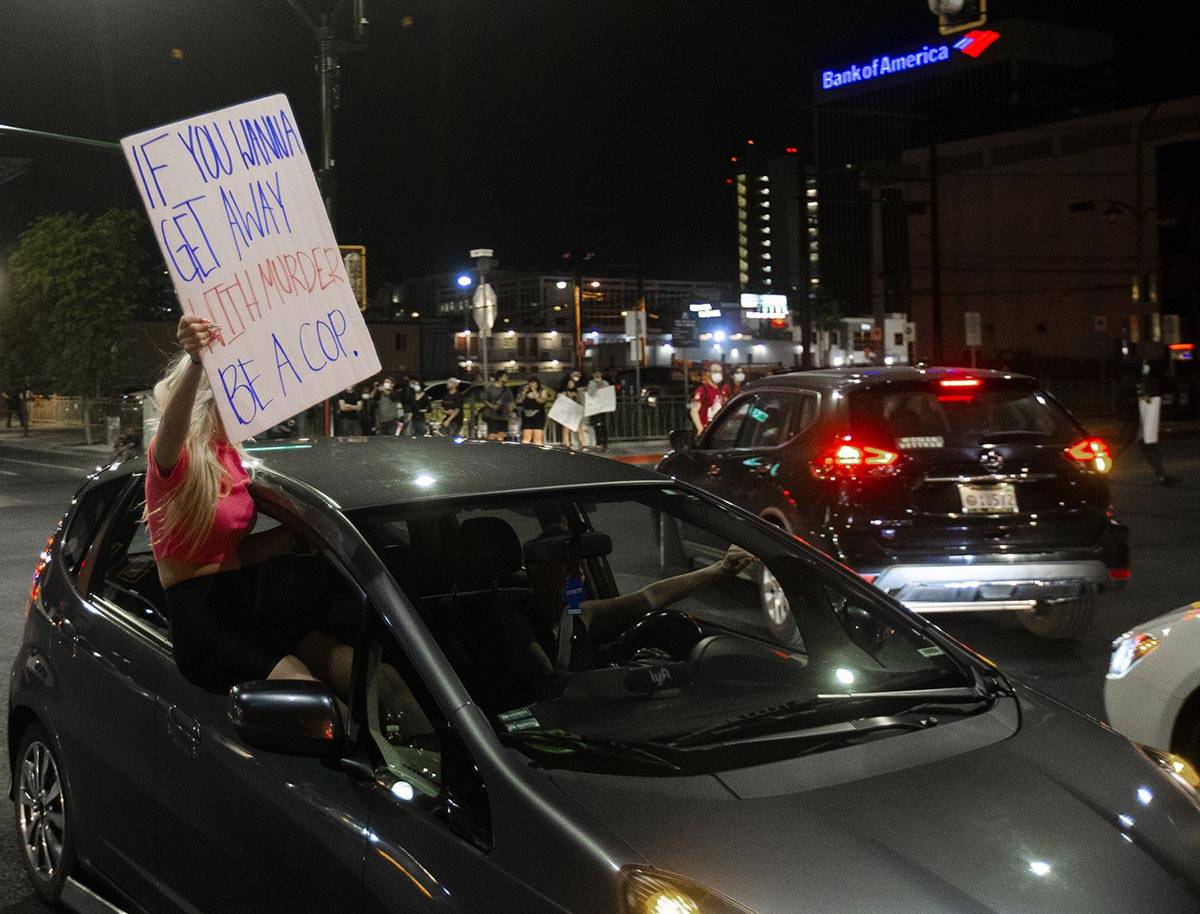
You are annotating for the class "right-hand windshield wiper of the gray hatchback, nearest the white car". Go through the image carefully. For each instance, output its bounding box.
[667,688,994,748]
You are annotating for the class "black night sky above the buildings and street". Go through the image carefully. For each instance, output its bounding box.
[0,0,1198,284]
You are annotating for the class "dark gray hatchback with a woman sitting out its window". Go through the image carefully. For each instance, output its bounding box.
[8,439,1200,914]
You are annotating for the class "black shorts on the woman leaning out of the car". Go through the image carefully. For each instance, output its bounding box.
[164,555,325,692]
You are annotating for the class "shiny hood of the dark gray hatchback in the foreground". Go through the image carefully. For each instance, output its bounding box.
[553,688,1200,914]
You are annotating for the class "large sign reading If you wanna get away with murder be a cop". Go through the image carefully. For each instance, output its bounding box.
[121,95,379,441]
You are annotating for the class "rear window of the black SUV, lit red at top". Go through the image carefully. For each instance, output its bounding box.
[850,381,1078,450]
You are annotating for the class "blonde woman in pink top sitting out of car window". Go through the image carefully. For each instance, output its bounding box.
[145,314,420,720]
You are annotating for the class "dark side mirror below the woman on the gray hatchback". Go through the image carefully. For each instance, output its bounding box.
[229,679,346,758]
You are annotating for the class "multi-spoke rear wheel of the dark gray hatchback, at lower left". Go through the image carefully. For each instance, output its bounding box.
[13,723,76,904]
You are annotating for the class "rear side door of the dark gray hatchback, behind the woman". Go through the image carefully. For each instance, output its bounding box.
[50,476,170,909]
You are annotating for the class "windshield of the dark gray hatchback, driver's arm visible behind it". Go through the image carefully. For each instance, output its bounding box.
[353,487,978,770]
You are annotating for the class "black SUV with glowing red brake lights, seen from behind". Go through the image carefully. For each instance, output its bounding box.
[659,367,1129,638]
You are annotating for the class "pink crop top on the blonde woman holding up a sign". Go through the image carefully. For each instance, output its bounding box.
[146,440,257,565]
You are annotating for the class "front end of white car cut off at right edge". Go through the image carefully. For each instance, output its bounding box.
[1104,601,1200,763]
